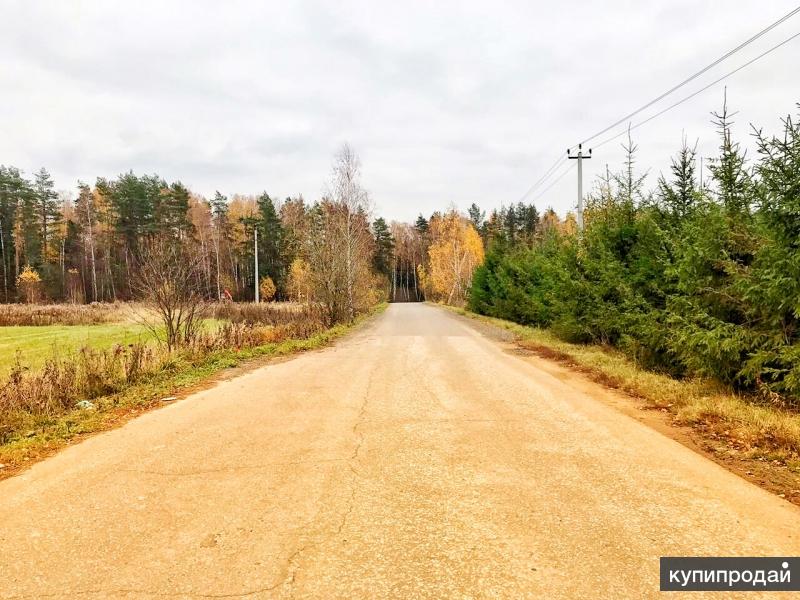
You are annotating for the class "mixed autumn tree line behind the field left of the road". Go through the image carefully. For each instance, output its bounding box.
[0,146,390,321]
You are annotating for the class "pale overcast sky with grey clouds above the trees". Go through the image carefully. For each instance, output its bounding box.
[0,0,800,220]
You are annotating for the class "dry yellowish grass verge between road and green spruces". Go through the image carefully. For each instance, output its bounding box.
[446,309,800,473]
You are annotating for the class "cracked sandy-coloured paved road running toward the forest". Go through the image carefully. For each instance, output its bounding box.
[0,304,800,599]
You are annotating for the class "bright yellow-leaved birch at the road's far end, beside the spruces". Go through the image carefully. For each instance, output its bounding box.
[419,210,484,305]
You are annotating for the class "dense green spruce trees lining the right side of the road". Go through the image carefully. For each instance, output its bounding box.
[469,102,800,405]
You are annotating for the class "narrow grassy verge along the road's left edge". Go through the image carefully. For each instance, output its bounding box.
[0,304,387,479]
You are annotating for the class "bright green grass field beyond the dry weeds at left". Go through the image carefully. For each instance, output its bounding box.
[0,322,153,375]
